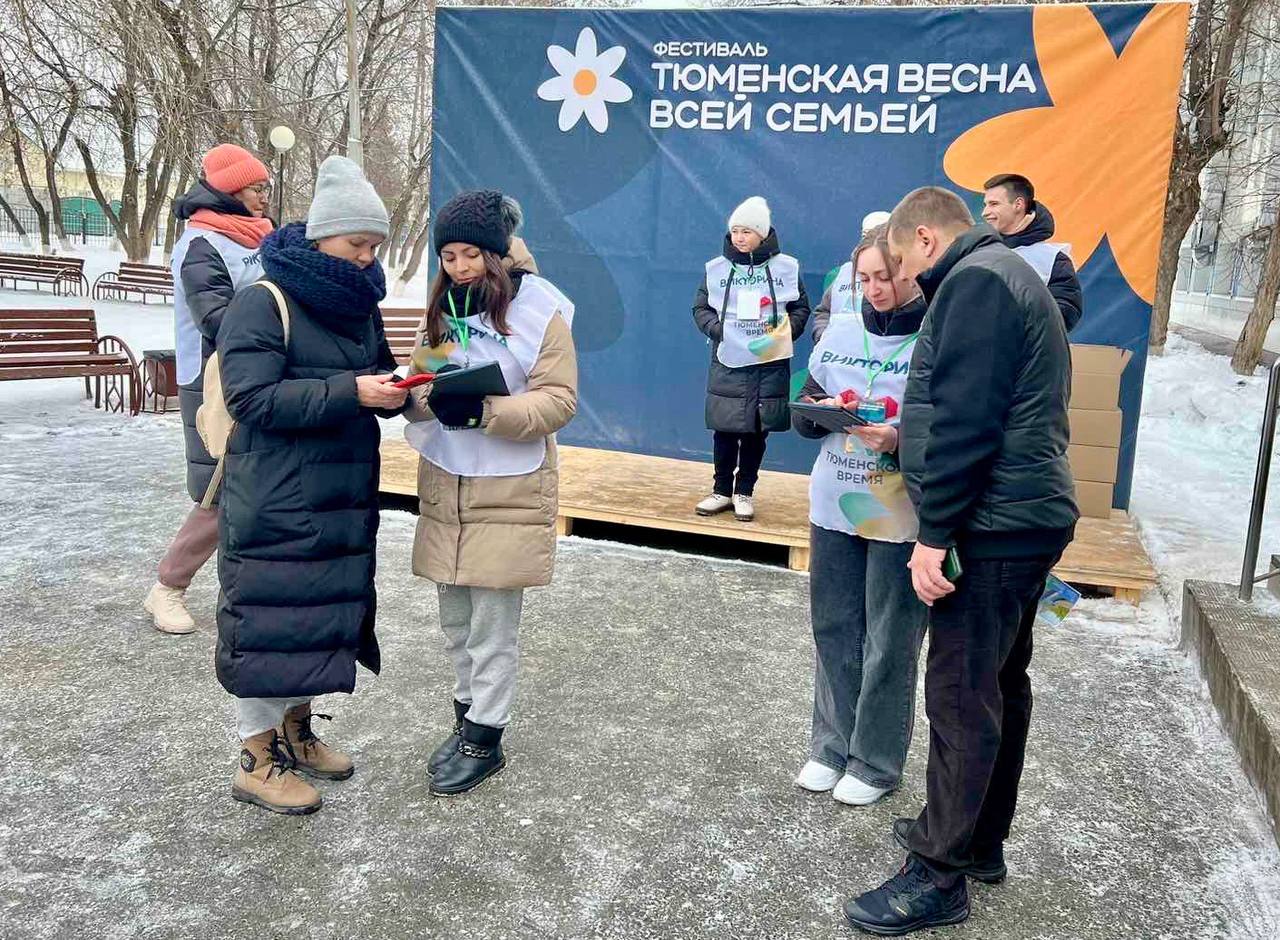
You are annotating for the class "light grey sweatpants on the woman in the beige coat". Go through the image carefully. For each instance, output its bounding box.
[436,584,525,727]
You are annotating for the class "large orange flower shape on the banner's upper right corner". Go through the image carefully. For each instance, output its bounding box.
[943,4,1189,304]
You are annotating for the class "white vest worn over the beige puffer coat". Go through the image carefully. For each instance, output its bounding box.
[404,274,573,476]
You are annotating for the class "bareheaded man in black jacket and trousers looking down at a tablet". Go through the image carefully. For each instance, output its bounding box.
[845,187,1079,935]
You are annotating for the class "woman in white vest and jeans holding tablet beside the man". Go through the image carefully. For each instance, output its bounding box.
[795,225,927,806]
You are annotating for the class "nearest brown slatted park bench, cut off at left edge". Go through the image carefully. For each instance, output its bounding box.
[0,307,141,415]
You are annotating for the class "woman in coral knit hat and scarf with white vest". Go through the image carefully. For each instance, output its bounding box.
[143,143,273,634]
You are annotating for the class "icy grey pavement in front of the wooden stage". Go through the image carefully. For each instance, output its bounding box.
[0,295,1280,940]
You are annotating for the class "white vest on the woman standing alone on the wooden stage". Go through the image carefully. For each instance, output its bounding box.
[707,255,800,369]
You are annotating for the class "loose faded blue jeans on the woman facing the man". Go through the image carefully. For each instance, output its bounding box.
[809,525,928,789]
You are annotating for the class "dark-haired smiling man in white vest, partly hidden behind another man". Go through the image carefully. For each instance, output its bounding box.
[982,173,1084,333]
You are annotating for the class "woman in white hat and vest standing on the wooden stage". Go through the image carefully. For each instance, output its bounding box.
[694,196,809,523]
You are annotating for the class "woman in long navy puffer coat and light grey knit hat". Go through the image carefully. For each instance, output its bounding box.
[216,158,406,813]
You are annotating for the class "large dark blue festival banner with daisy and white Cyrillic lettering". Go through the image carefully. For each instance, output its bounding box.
[431,3,1188,507]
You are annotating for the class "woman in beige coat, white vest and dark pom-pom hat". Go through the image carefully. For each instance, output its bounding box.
[404,191,577,795]
